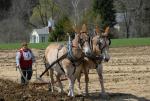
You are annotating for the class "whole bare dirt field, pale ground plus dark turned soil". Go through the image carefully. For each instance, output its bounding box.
[0,46,150,101]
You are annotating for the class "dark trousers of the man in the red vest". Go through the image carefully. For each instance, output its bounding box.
[21,67,33,84]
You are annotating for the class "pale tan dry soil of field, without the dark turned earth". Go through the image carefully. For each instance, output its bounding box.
[0,46,150,101]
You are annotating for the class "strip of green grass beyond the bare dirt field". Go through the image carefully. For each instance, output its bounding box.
[0,38,150,49]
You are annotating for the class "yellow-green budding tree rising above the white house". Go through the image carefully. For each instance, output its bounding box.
[30,0,60,27]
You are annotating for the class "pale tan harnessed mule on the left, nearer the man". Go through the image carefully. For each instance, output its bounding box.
[45,25,90,96]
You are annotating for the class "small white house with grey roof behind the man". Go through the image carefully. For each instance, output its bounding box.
[30,27,49,43]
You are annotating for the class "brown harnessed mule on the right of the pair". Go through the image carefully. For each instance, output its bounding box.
[77,27,110,95]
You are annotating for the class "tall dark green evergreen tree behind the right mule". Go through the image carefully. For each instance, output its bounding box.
[93,0,116,27]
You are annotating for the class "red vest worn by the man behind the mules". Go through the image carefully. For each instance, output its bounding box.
[19,49,32,69]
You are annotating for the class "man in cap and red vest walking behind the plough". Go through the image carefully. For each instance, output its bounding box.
[16,42,35,85]
